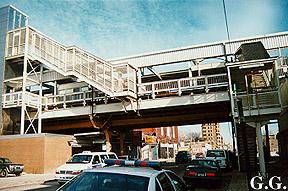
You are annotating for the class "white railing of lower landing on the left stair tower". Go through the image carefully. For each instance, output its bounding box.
[2,91,42,108]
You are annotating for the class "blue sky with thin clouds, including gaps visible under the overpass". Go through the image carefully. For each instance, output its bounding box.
[0,0,288,142]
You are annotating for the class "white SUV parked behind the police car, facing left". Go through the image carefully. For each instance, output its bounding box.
[55,151,118,185]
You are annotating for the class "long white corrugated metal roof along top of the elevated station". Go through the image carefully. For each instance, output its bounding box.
[110,32,288,68]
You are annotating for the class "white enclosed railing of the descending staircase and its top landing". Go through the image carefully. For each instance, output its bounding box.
[6,27,136,96]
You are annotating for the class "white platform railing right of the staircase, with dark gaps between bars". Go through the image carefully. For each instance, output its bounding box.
[138,74,228,98]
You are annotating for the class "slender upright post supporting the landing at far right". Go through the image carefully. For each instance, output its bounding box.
[255,123,266,177]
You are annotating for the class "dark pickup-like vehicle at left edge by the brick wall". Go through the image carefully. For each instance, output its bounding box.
[0,158,24,177]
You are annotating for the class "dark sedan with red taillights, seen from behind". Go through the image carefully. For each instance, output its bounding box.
[183,158,221,187]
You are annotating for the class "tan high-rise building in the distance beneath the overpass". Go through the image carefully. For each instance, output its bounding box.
[201,123,223,149]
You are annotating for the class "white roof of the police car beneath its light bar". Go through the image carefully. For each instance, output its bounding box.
[84,166,167,177]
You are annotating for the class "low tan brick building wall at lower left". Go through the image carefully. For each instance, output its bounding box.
[0,134,72,174]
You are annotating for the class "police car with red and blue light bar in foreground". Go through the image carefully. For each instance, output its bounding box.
[58,159,187,191]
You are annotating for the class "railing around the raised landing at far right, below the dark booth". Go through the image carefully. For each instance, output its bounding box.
[234,90,281,111]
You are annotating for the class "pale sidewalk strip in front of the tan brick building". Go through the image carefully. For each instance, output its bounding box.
[0,173,55,190]
